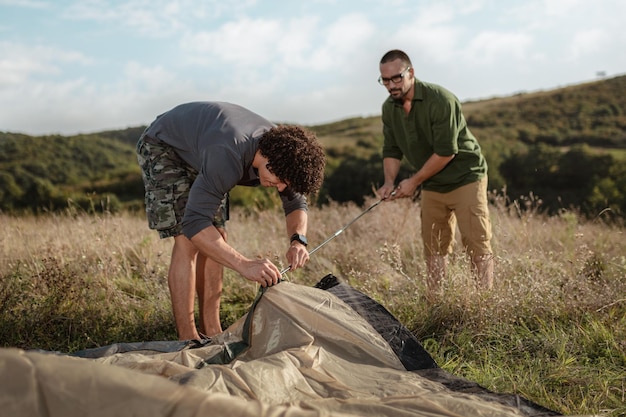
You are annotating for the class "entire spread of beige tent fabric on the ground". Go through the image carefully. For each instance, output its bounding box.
[0,282,564,417]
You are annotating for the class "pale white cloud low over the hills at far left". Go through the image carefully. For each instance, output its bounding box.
[0,54,196,134]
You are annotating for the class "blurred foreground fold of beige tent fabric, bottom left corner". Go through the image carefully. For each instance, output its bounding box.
[0,349,319,417]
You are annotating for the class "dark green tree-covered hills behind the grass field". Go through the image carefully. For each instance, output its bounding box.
[0,76,626,221]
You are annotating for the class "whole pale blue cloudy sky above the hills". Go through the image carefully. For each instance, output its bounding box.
[0,0,626,135]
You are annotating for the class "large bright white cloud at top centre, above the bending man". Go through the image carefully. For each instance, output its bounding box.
[181,14,375,89]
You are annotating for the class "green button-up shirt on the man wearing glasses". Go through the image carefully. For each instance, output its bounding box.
[382,79,487,193]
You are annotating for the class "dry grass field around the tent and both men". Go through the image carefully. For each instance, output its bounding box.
[0,196,626,416]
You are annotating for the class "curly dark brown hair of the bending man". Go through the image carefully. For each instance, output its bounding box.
[259,125,326,194]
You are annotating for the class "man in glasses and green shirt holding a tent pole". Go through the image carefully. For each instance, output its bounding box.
[378,49,493,293]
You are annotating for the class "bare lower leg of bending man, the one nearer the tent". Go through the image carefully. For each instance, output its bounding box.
[196,255,224,336]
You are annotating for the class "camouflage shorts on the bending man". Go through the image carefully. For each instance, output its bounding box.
[137,135,228,238]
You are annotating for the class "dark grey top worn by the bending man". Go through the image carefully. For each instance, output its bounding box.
[145,102,307,238]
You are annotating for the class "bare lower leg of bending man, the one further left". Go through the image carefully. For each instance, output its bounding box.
[167,234,200,340]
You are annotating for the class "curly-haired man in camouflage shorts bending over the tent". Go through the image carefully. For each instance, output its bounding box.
[137,102,325,340]
